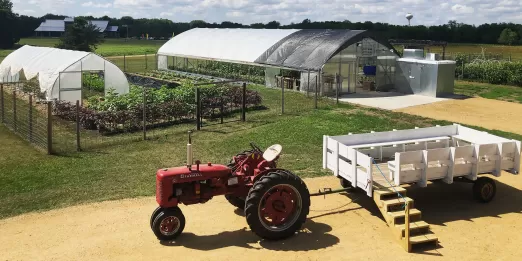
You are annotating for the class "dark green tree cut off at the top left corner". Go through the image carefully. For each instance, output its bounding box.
[0,0,20,49]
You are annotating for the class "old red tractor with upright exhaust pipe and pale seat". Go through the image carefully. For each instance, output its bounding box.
[150,132,310,240]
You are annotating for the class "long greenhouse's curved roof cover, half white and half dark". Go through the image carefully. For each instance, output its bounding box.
[158,28,397,71]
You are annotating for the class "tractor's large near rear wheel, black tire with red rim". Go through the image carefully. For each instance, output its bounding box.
[245,170,310,240]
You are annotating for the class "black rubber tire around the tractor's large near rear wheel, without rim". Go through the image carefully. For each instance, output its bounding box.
[245,170,310,240]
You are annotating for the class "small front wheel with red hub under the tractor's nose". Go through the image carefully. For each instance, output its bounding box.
[152,207,185,240]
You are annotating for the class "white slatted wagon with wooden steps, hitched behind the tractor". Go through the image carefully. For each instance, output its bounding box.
[323,124,521,251]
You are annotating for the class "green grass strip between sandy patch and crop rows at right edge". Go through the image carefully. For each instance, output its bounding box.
[455,81,522,103]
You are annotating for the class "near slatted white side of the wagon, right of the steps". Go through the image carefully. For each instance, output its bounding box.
[388,141,520,187]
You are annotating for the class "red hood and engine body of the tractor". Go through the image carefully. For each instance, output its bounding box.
[156,162,231,207]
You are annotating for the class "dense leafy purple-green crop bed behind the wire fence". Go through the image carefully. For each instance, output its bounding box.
[53,83,262,134]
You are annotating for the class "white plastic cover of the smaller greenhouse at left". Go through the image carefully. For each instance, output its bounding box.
[0,45,129,99]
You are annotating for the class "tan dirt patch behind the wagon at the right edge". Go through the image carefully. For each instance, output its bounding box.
[396,98,522,134]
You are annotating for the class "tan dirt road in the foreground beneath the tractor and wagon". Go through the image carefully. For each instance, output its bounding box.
[0,173,522,261]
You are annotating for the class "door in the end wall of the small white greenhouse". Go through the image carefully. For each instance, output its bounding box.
[58,72,82,104]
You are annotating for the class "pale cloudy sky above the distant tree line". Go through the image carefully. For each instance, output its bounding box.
[12,0,522,25]
